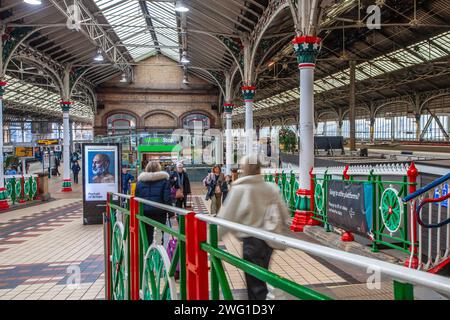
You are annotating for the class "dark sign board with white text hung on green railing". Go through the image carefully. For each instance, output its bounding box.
[327,180,373,236]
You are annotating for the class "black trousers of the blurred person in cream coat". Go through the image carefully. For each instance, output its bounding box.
[243,237,273,300]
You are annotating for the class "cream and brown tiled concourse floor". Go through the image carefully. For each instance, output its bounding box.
[0,168,392,300]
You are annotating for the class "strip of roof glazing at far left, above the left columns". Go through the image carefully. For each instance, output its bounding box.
[3,75,94,121]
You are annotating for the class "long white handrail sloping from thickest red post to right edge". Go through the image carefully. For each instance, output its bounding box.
[195,214,450,293]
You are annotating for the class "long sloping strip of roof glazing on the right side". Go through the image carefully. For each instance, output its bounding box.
[246,31,450,114]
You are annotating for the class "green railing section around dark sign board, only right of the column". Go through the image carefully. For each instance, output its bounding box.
[312,165,416,253]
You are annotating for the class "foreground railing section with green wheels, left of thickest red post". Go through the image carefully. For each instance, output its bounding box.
[105,193,193,300]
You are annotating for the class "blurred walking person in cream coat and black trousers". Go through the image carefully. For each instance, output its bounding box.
[217,157,290,300]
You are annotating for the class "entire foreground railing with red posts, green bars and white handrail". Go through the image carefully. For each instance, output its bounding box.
[105,185,450,300]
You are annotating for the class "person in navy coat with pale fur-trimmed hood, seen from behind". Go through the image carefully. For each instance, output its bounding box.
[135,161,172,245]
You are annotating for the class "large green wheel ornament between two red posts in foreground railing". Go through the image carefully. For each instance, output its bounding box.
[139,244,178,300]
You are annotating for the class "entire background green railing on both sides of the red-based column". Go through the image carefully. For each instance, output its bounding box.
[263,164,418,262]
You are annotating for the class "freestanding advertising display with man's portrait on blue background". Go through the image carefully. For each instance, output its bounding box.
[82,144,121,224]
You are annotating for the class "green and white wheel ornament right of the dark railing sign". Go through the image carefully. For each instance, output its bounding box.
[380,186,403,234]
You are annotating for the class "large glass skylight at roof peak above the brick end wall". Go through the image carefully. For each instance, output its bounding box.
[94,0,180,62]
